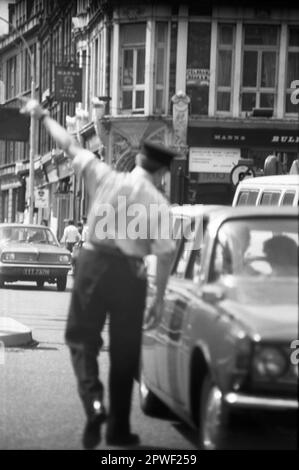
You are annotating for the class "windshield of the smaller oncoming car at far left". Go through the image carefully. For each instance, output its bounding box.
[0,226,58,246]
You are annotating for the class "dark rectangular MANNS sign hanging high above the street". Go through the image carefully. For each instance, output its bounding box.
[55,66,82,103]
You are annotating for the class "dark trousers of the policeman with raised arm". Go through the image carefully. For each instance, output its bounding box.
[66,248,146,433]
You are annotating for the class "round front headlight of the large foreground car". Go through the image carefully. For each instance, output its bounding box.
[253,347,288,378]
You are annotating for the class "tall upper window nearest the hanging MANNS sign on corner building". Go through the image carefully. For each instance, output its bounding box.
[120,23,145,113]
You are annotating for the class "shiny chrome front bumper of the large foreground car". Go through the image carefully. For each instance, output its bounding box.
[223,392,299,411]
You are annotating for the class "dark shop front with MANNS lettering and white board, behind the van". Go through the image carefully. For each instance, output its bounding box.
[185,121,299,205]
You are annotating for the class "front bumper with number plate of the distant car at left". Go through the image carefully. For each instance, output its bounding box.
[0,263,71,281]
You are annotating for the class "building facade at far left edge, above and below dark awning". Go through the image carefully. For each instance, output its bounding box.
[0,0,42,222]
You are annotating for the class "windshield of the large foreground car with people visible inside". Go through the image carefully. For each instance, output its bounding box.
[212,218,298,279]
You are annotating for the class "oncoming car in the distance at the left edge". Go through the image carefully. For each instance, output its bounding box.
[0,223,71,291]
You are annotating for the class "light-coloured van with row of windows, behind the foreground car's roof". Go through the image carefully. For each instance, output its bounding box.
[233,175,299,206]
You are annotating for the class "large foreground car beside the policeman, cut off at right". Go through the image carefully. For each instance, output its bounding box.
[139,206,299,450]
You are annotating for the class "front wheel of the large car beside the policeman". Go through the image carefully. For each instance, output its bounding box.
[199,374,229,450]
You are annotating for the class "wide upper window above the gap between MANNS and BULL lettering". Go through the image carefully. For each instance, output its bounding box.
[241,25,279,111]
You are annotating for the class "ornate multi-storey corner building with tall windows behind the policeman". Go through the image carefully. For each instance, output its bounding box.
[0,0,299,234]
